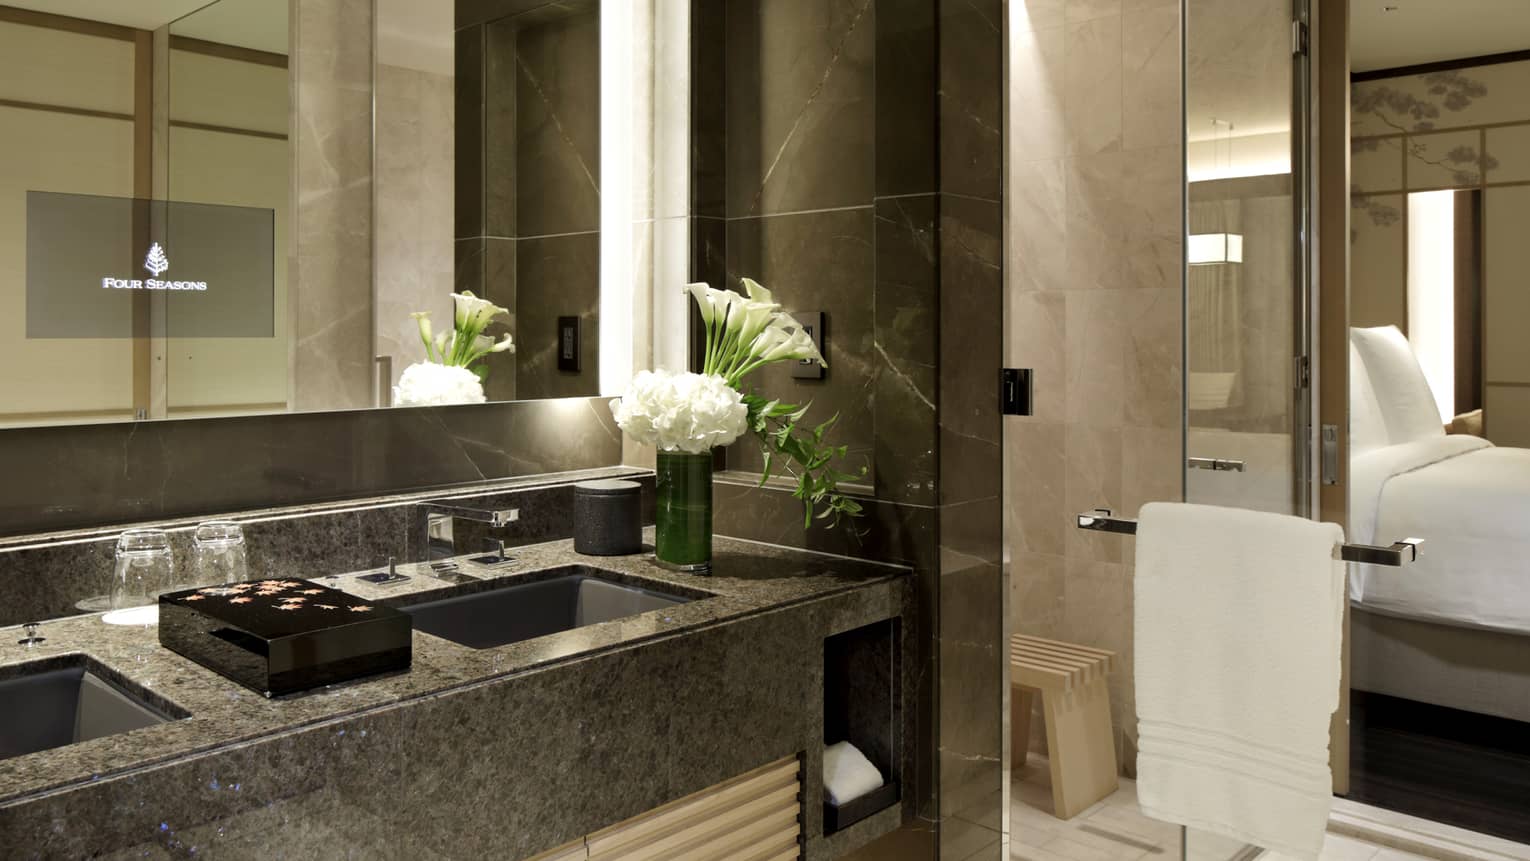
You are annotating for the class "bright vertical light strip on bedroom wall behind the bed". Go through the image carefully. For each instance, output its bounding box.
[1408,191,1455,422]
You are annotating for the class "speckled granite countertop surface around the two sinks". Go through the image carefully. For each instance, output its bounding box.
[0,529,907,807]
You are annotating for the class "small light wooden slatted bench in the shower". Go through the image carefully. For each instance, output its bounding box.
[1010,635,1120,820]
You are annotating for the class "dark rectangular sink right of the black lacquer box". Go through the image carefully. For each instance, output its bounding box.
[399,567,695,648]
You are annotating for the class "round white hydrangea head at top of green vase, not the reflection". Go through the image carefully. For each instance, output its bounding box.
[610,370,748,454]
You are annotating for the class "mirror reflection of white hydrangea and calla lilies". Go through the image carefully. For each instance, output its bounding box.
[393,291,516,407]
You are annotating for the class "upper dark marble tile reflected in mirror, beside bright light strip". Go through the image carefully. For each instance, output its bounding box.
[505,8,600,237]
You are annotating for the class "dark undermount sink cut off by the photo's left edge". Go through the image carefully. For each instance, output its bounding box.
[0,655,188,760]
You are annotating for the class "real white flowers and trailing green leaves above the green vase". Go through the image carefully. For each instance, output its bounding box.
[610,278,868,528]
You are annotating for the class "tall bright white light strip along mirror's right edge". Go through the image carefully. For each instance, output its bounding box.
[600,3,633,395]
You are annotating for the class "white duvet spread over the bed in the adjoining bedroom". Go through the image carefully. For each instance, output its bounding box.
[1349,436,1530,632]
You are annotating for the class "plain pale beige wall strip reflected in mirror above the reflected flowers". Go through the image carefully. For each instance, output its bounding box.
[375,63,456,382]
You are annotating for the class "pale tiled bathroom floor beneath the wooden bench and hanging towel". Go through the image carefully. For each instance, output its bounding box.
[1010,757,1426,861]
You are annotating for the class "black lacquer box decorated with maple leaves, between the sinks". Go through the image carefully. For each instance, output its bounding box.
[159,580,413,696]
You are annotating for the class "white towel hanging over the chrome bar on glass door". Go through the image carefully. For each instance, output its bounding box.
[1134,503,1345,858]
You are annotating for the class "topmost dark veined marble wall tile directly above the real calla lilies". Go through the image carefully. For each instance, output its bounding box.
[727,0,877,217]
